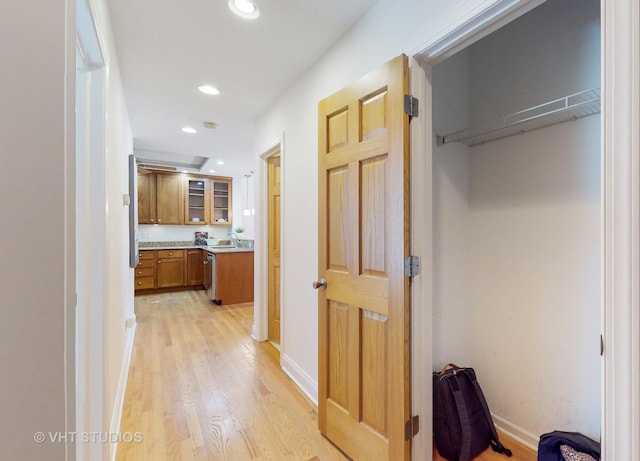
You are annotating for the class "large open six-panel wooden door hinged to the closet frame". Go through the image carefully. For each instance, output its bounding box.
[314,56,411,461]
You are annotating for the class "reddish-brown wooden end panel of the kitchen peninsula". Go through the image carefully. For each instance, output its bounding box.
[216,251,253,304]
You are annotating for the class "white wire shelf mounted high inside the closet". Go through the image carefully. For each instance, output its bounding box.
[438,88,600,146]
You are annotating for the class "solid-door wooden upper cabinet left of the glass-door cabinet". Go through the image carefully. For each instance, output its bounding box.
[138,171,184,224]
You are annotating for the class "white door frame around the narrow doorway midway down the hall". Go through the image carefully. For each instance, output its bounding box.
[251,137,286,352]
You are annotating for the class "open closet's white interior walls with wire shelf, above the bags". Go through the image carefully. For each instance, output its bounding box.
[431,0,603,447]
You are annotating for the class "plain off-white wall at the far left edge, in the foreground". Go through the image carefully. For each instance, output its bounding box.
[0,0,75,460]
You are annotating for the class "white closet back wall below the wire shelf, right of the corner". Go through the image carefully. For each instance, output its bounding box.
[469,116,601,438]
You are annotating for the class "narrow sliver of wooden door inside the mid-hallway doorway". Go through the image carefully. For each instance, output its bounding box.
[267,155,280,343]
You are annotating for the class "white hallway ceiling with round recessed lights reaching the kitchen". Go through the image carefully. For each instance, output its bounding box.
[107,0,377,176]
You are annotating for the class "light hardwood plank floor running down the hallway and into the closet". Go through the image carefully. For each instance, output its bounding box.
[116,291,536,461]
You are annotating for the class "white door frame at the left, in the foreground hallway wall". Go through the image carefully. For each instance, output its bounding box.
[75,0,107,459]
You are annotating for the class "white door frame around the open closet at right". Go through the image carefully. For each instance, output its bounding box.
[404,0,640,461]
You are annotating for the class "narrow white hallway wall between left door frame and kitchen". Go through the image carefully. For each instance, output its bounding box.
[95,0,135,450]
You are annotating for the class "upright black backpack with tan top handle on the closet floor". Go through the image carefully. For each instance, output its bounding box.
[433,363,511,461]
